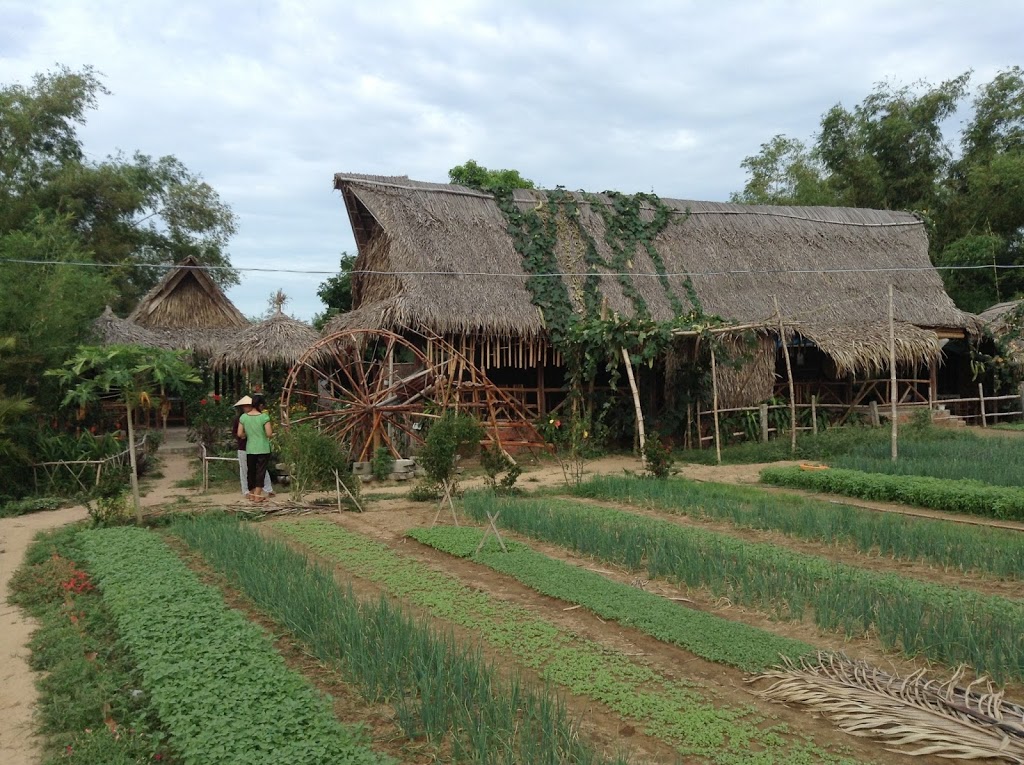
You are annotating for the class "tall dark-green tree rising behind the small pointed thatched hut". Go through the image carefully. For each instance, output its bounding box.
[0,67,238,319]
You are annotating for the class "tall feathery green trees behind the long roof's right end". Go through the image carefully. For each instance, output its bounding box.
[732,67,1024,311]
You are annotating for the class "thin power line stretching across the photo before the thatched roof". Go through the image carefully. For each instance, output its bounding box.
[0,258,1024,279]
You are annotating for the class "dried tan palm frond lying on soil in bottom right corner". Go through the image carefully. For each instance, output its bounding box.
[752,652,1024,764]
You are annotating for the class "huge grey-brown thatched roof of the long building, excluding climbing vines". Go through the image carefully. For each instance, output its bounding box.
[326,174,976,371]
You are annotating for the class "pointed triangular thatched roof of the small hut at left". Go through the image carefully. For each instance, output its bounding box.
[128,256,249,330]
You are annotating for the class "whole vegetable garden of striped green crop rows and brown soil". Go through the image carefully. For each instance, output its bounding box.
[8,428,1024,765]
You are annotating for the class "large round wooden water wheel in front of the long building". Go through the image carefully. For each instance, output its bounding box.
[281,330,545,462]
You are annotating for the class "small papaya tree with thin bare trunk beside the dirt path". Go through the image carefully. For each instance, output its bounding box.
[46,345,200,523]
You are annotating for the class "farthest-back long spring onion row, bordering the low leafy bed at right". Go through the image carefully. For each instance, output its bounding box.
[571,471,1024,579]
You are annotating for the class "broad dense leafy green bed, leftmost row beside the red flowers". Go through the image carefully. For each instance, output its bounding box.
[82,527,389,765]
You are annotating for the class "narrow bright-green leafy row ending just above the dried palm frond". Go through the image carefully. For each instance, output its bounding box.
[409,526,814,672]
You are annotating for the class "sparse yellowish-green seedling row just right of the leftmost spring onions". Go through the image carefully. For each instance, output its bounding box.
[273,519,851,765]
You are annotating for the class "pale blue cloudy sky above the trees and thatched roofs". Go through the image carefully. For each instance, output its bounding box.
[0,0,1024,320]
